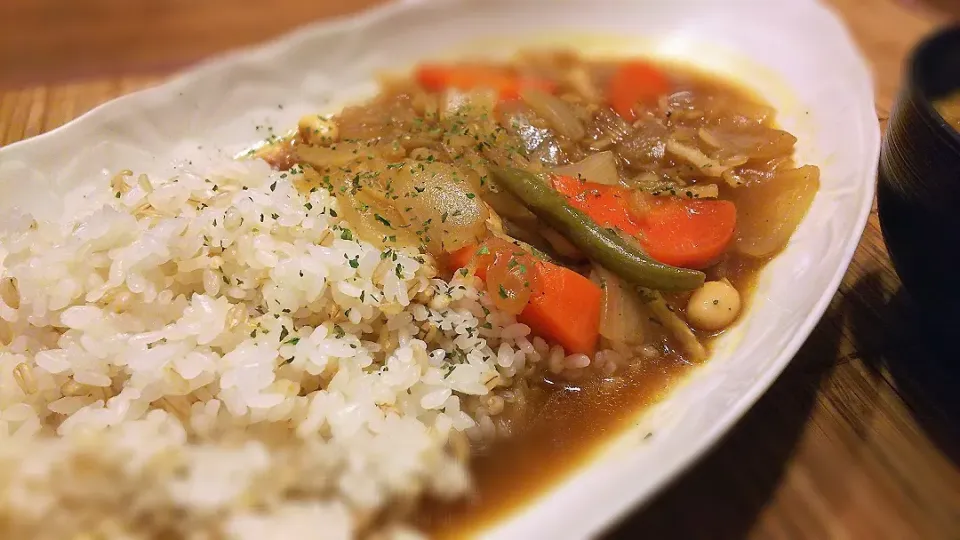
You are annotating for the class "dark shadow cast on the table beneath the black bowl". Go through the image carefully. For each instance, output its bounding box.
[848,274,960,466]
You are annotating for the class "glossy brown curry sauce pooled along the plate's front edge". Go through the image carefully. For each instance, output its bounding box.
[414,255,769,538]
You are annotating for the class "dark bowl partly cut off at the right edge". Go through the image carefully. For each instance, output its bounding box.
[877,27,960,325]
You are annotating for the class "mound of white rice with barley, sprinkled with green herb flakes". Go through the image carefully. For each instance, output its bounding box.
[0,162,564,540]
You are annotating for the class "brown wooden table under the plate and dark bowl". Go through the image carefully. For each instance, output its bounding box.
[0,0,960,539]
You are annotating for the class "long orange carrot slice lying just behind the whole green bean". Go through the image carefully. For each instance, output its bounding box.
[552,176,737,268]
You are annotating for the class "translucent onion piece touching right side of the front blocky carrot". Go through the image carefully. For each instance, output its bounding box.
[591,266,647,348]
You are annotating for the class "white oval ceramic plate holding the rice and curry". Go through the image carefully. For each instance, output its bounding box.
[0,0,880,539]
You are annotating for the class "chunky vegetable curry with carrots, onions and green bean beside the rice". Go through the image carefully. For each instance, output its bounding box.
[258,52,819,396]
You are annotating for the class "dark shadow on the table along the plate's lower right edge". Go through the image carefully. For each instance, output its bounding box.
[604,305,844,540]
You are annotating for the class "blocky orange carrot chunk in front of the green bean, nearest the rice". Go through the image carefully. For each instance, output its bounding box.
[517,261,602,356]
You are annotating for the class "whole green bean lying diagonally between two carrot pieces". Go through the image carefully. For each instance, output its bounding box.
[490,167,706,291]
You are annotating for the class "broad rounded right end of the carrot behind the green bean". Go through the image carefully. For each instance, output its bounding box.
[640,197,737,268]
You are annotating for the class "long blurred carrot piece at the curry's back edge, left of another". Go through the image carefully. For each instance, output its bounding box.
[415,64,556,101]
